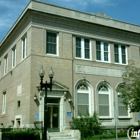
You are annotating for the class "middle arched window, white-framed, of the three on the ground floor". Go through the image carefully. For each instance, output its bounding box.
[98,82,111,117]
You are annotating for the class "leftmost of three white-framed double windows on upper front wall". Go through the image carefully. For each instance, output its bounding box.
[76,37,91,59]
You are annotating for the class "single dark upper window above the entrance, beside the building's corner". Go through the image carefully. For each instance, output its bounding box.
[46,32,58,55]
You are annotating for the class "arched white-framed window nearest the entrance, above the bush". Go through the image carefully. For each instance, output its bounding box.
[76,83,89,116]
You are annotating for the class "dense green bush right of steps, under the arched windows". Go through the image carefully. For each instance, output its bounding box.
[70,112,103,137]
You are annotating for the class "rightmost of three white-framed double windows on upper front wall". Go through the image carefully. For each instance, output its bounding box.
[114,44,126,64]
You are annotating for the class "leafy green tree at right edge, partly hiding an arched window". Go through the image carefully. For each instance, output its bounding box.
[117,60,140,112]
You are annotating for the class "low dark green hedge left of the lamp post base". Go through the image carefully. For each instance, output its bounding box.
[2,130,40,140]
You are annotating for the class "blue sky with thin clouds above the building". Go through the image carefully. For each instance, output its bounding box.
[0,0,140,42]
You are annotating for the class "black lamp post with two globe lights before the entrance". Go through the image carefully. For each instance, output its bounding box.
[39,66,54,140]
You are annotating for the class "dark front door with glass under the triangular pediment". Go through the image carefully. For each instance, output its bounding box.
[47,98,60,132]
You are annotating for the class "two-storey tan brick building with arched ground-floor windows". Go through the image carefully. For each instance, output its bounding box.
[0,1,140,131]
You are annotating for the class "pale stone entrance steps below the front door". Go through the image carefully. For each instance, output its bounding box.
[48,130,80,140]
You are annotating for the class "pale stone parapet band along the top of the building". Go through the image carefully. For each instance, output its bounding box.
[0,0,140,46]
